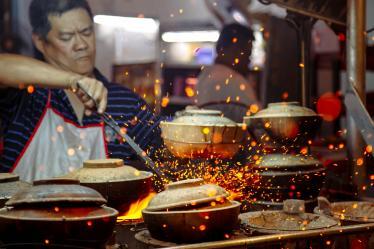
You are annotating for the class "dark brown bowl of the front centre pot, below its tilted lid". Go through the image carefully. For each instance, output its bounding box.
[142,201,241,243]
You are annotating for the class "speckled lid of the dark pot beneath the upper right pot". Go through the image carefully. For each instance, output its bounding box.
[254,154,322,169]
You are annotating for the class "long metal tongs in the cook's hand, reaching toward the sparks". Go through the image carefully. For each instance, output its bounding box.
[77,83,167,179]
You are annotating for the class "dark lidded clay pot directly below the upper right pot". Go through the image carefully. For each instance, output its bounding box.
[251,154,326,209]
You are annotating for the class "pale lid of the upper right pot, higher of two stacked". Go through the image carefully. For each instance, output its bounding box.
[247,102,318,118]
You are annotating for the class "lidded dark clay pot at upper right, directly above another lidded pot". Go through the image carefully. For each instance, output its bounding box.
[244,102,322,147]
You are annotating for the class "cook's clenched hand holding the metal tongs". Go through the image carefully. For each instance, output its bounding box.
[71,77,108,116]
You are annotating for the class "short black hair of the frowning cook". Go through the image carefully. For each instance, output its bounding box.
[29,0,92,39]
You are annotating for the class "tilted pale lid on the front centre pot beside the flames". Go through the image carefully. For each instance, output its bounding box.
[146,178,229,211]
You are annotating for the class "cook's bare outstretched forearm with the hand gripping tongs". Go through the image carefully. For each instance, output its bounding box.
[0,54,107,113]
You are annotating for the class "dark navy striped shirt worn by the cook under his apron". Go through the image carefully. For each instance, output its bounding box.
[0,70,162,172]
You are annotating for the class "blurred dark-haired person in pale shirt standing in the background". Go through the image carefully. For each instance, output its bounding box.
[195,23,259,122]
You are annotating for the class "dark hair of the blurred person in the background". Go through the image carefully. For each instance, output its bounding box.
[216,23,254,53]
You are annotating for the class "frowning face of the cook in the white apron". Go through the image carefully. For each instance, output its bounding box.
[36,8,96,75]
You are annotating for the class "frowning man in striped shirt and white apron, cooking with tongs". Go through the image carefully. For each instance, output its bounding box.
[0,0,161,181]
